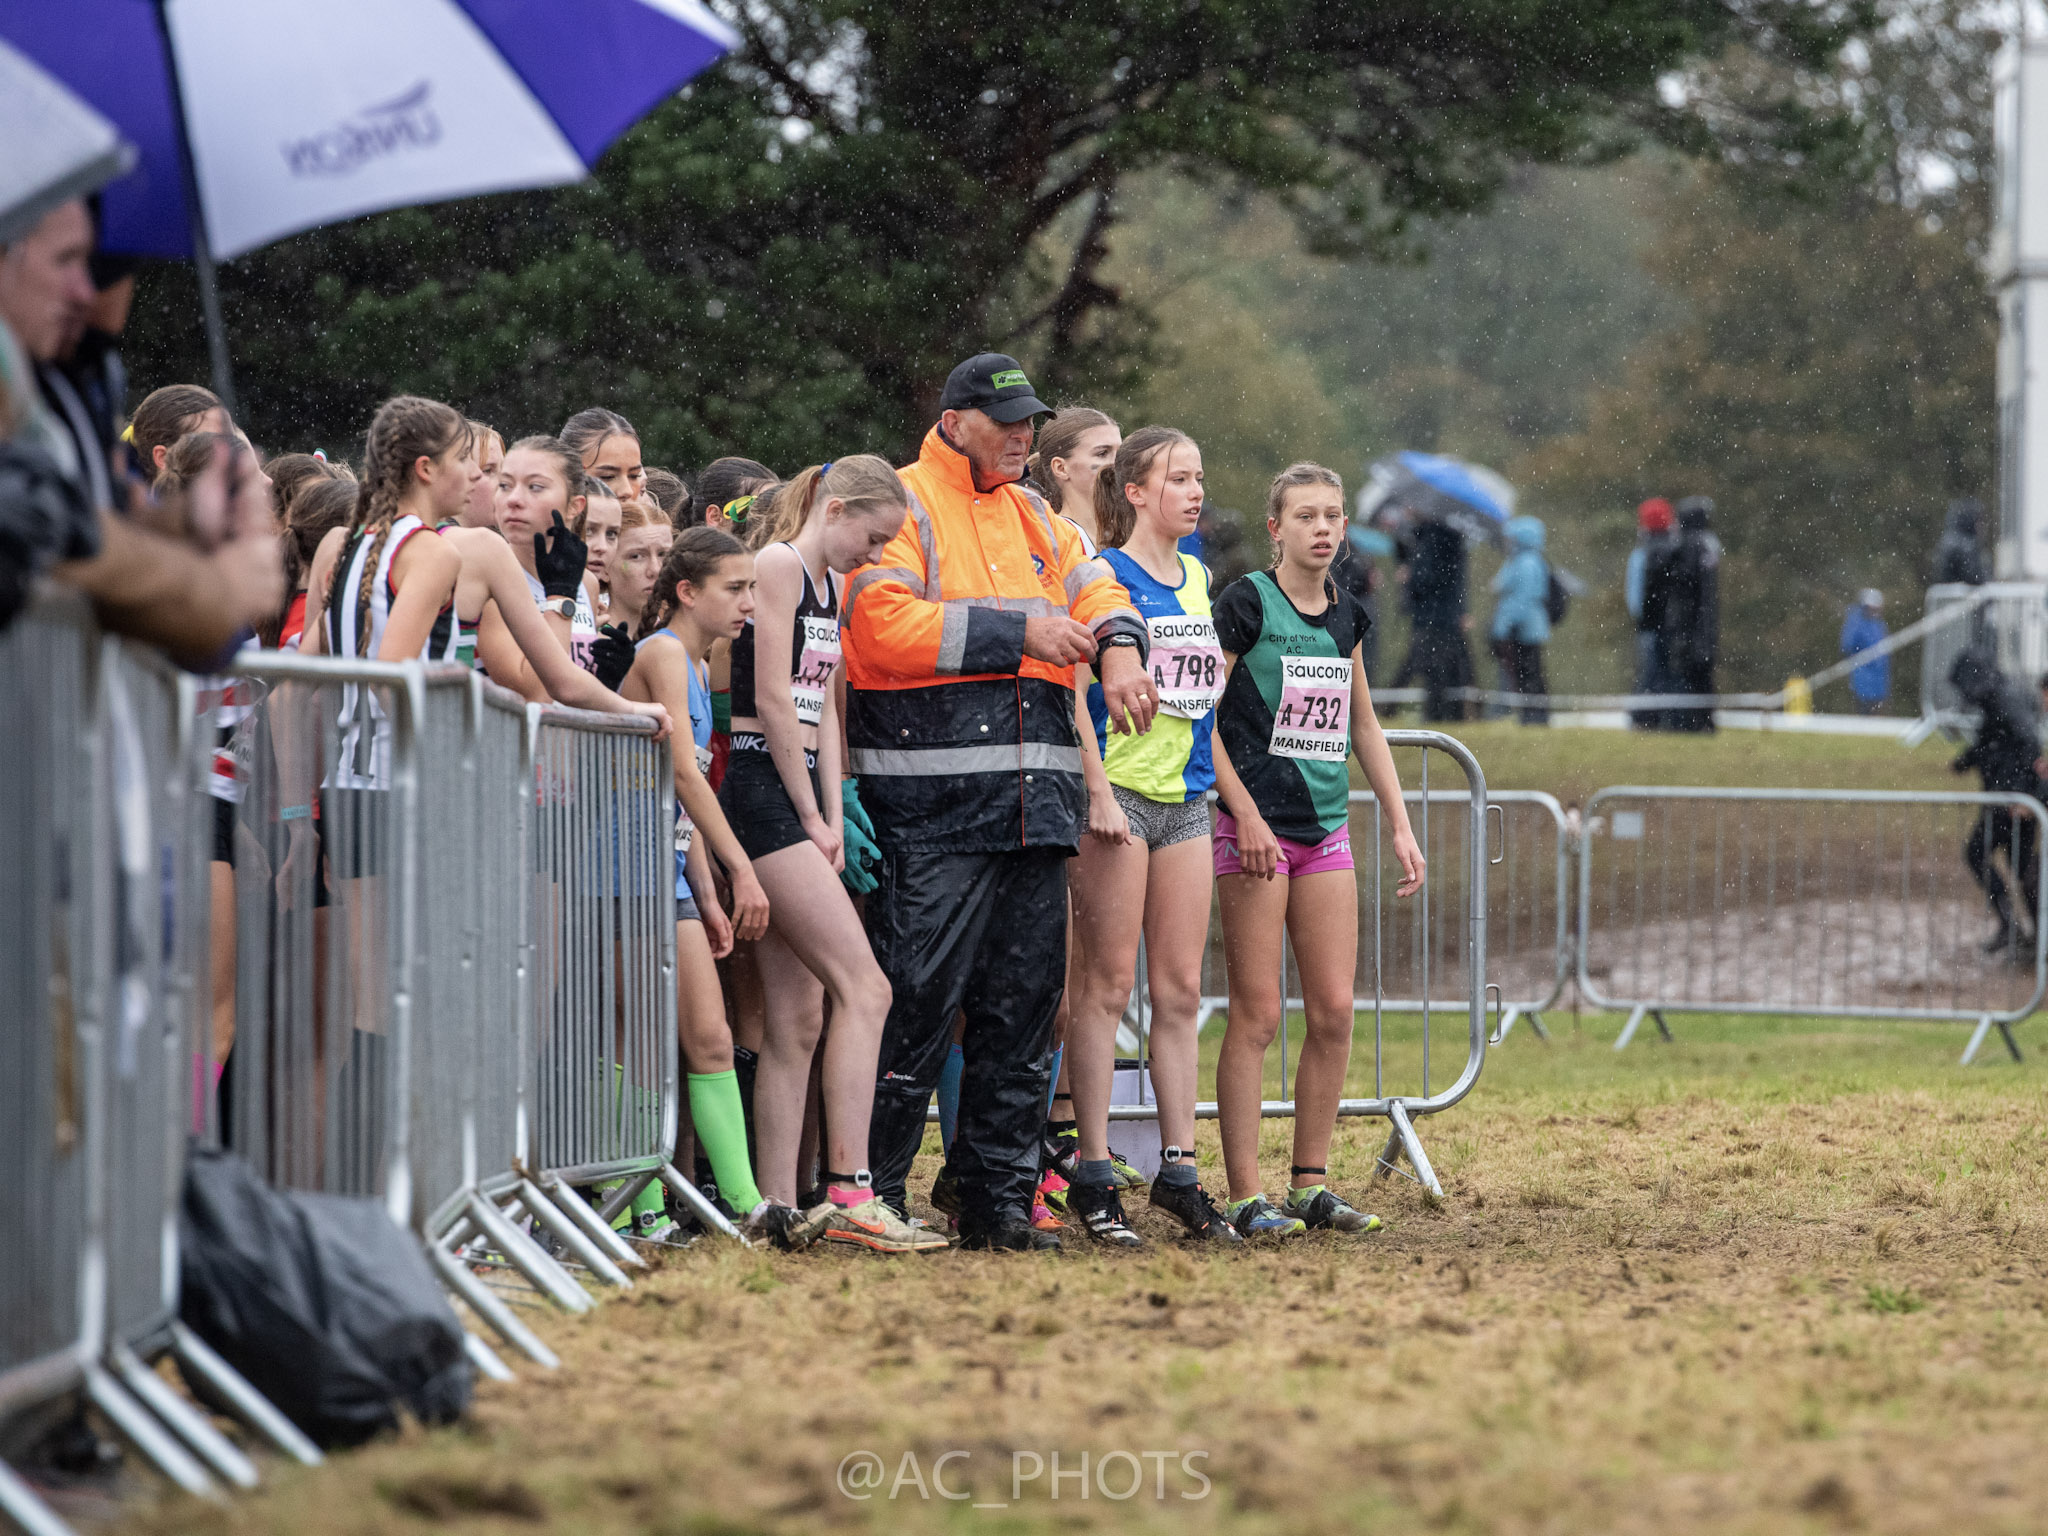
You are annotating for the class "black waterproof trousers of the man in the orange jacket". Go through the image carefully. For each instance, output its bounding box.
[866,848,1071,1237]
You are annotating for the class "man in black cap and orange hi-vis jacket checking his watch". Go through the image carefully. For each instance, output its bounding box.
[842,352,1157,1249]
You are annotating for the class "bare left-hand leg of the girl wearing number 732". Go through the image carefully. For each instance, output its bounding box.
[1217,874,1290,1200]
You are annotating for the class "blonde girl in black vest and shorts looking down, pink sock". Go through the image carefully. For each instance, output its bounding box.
[719,455,946,1253]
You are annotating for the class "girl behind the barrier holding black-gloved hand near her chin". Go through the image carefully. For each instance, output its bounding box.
[495,438,598,679]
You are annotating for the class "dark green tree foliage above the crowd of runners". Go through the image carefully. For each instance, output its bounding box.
[131,0,1870,467]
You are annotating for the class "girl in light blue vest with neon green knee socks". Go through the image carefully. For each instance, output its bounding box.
[625,528,797,1247]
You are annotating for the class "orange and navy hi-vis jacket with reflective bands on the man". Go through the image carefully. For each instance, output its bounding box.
[840,426,1147,854]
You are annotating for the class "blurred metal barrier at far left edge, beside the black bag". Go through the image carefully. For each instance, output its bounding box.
[0,594,319,1536]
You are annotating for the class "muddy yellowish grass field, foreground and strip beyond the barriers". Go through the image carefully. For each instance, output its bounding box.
[103,727,2048,1536]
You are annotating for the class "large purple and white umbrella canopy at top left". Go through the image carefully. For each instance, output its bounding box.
[0,0,737,258]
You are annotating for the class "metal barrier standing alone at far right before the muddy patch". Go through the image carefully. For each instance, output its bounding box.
[1579,786,2048,1065]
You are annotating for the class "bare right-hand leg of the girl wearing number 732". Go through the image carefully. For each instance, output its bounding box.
[1286,870,1358,1188]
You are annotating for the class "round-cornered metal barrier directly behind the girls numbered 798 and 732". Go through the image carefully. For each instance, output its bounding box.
[1110,731,1490,1196]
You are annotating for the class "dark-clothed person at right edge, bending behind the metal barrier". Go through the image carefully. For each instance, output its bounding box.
[1948,649,2042,958]
